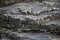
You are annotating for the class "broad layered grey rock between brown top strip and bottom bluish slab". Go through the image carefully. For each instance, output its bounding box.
[0,2,60,33]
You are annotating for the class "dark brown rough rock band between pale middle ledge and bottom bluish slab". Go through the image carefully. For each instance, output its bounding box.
[0,15,60,34]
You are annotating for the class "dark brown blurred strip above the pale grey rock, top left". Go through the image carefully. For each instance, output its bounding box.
[0,0,42,6]
